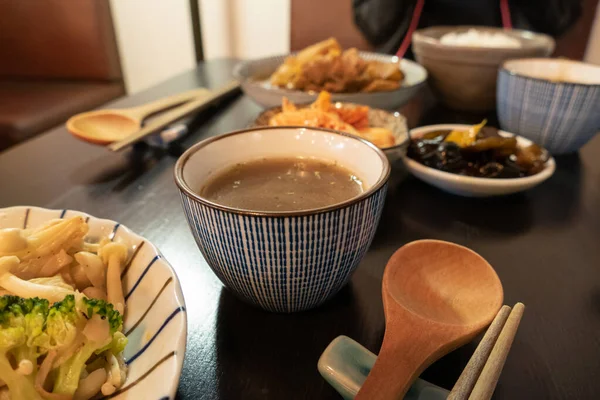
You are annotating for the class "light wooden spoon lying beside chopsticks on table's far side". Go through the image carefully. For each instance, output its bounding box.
[67,88,210,145]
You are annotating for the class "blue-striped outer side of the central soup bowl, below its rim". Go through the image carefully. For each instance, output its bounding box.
[181,185,387,312]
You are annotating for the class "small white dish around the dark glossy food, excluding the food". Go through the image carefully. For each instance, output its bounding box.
[404,124,556,197]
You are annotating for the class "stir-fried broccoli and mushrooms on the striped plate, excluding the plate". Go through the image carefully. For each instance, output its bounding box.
[0,217,128,400]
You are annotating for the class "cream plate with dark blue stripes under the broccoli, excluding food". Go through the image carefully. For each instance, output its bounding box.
[0,207,187,400]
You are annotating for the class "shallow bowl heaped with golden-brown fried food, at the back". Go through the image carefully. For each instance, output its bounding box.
[234,39,427,110]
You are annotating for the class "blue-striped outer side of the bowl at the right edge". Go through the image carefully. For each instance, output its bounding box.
[497,69,600,154]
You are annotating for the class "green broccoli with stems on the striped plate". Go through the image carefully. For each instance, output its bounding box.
[0,295,127,400]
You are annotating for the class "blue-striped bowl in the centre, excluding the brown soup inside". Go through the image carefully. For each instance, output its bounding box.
[175,127,390,312]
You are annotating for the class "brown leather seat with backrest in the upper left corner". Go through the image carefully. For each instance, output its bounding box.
[0,0,125,150]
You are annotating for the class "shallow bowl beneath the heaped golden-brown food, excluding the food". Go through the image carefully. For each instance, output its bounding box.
[233,52,427,110]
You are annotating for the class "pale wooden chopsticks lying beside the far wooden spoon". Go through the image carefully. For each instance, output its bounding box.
[107,81,240,151]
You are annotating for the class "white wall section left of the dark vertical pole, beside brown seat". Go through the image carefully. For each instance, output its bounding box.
[110,0,197,93]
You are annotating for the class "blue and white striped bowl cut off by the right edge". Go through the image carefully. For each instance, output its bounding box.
[496,58,600,154]
